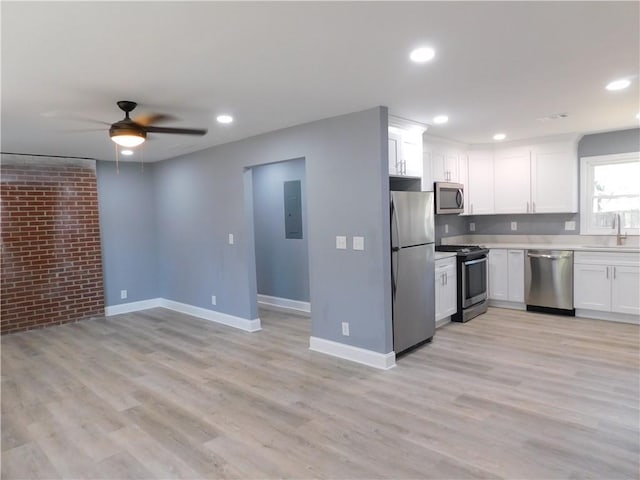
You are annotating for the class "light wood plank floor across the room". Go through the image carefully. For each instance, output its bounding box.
[2,309,640,479]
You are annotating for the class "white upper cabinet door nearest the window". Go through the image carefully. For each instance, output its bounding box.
[531,142,578,213]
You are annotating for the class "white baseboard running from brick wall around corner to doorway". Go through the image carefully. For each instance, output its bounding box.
[104,298,261,332]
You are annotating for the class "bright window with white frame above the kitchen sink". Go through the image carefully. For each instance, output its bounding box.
[580,152,640,235]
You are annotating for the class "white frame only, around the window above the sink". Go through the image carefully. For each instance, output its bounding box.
[580,152,640,235]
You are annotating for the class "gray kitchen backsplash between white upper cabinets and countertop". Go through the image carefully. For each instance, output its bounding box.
[435,213,580,244]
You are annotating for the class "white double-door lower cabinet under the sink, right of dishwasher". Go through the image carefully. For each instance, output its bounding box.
[573,252,640,318]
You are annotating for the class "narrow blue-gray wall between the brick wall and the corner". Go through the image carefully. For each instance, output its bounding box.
[96,161,158,306]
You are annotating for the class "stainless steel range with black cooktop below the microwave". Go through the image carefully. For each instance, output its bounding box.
[436,245,489,322]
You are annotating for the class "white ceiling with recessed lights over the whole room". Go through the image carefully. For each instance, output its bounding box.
[1,1,640,161]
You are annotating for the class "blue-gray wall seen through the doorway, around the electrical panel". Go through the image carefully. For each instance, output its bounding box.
[251,158,309,302]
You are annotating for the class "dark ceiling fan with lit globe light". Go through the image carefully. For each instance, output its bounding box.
[109,100,207,147]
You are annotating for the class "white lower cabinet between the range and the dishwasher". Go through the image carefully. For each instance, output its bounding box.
[489,248,524,304]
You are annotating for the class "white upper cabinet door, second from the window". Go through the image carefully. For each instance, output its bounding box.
[494,149,531,213]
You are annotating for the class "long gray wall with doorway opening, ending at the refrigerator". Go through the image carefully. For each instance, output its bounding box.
[154,107,393,353]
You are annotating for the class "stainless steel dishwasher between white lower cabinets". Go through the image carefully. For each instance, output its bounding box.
[524,250,575,315]
